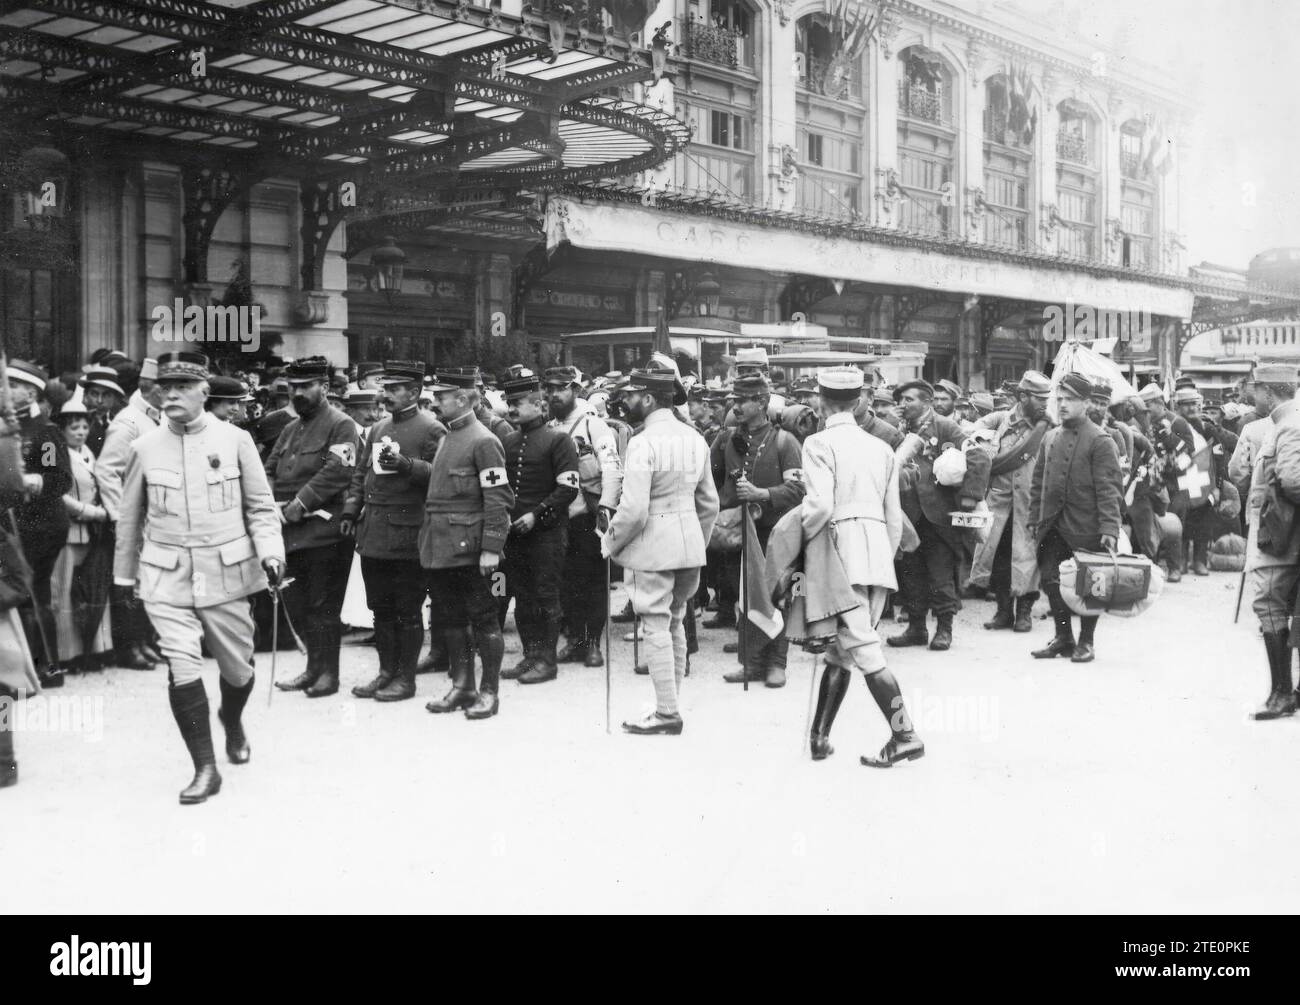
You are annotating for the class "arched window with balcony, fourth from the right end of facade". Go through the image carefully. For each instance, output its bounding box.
[898,46,957,235]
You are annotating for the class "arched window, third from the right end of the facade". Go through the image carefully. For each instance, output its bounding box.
[984,68,1039,250]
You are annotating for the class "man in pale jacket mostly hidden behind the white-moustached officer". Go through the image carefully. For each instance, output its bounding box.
[95,359,163,670]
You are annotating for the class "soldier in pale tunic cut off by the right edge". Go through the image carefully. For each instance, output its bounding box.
[1245,363,1300,722]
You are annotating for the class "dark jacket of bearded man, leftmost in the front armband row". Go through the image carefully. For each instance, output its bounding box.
[267,403,359,551]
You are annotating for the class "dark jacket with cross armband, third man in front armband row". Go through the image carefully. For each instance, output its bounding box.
[420,412,515,568]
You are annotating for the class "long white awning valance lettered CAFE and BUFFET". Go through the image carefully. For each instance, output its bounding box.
[546,196,1192,317]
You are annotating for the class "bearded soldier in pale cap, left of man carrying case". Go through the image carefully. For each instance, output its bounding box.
[970,371,1052,632]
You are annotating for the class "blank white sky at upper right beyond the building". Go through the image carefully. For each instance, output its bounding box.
[1055,0,1300,268]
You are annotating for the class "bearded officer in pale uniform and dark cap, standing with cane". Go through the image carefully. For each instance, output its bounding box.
[601,371,718,736]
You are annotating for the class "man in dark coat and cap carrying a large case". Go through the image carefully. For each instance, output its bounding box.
[1030,373,1123,663]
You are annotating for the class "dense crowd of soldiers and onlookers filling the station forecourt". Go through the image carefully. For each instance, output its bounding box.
[0,348,1279,803]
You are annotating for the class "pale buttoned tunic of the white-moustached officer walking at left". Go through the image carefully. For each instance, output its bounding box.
[113,412,285,607]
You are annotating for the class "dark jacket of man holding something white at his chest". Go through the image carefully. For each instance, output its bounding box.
[343,404,447,562]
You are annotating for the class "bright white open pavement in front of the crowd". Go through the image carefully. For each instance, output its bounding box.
[0,573,1300,913]
